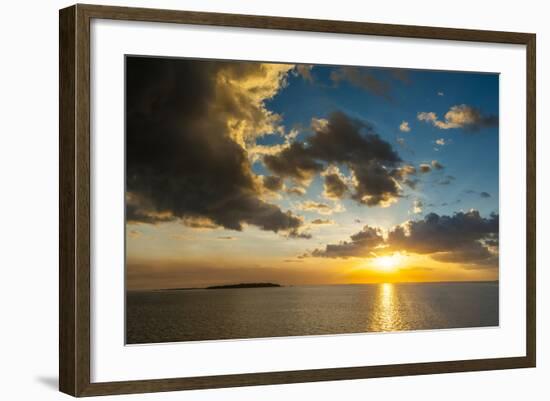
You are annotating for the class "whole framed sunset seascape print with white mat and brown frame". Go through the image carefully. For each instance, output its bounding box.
[60,5,536,396]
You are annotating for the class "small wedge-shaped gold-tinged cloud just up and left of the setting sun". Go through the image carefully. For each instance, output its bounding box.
[311,226,384,258]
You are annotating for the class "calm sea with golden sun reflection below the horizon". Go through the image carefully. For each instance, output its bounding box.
[126,282,499,344]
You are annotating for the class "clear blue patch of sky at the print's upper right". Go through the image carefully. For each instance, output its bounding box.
[254,66,499,228]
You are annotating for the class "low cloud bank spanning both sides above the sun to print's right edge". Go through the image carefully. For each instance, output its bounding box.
[308,210,499,268]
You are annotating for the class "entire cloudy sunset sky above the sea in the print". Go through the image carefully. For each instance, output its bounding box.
[126,56,499,289]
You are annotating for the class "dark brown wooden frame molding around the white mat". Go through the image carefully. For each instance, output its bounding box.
[59,4,536,396]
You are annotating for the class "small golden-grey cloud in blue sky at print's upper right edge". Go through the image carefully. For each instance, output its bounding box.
[417,104,498,131]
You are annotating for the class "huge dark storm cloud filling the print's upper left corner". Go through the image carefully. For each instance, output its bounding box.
[126,57,302,233]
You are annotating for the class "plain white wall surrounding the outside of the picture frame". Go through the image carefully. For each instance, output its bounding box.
[0,0,550,401]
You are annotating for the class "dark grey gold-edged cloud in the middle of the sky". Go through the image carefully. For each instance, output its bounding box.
[264,112,403,206]
